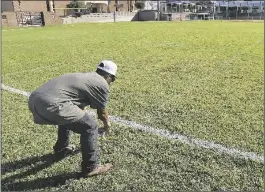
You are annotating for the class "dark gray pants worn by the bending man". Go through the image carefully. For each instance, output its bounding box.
[54,113,98,169]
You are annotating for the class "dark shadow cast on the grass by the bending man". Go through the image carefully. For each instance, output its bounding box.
[1,150,80,191]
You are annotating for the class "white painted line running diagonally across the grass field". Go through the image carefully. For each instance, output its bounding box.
[1,84,264,163]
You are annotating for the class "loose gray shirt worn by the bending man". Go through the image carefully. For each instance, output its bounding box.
[28,72,109,125]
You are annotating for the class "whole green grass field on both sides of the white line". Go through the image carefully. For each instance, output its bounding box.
[1,21,264,191]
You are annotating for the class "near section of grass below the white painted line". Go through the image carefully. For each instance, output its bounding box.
[2,92,264,191]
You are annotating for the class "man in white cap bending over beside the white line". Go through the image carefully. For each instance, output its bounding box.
[28,60,117,177]
